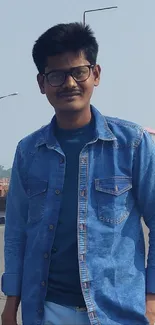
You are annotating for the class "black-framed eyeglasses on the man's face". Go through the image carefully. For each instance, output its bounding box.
[43,64,94,87]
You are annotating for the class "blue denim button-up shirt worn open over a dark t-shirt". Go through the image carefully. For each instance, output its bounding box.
[2,107,155,325]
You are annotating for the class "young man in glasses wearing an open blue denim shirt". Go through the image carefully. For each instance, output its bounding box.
[2,23,155,325]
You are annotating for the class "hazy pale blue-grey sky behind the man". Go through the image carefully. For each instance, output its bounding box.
[0,0,155,168]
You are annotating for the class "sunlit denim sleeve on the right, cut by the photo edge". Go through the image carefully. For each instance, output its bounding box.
[133,131,155,294]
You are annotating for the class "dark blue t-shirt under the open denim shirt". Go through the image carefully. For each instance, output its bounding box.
[46,119,95,307]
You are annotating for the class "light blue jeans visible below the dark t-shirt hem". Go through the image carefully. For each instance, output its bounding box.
[42,301,90,325]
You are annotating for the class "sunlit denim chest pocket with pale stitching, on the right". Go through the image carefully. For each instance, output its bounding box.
[95,176,132,226]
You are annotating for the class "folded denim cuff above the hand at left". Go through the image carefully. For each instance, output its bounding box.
[1,273,21,297]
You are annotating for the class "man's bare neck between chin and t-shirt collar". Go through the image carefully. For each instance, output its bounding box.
[56,108,91,129]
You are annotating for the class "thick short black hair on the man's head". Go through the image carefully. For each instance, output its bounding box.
[32,22,98,74]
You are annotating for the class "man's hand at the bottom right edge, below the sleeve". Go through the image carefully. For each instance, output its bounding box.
[146,294,155,325]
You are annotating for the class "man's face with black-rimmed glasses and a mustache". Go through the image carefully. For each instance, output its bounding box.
[37,53,100,112]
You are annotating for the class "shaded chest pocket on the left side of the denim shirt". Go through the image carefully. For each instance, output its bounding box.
[26,180,48,222]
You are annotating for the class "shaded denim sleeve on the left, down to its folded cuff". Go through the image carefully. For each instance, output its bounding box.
[1,144,28,296]
